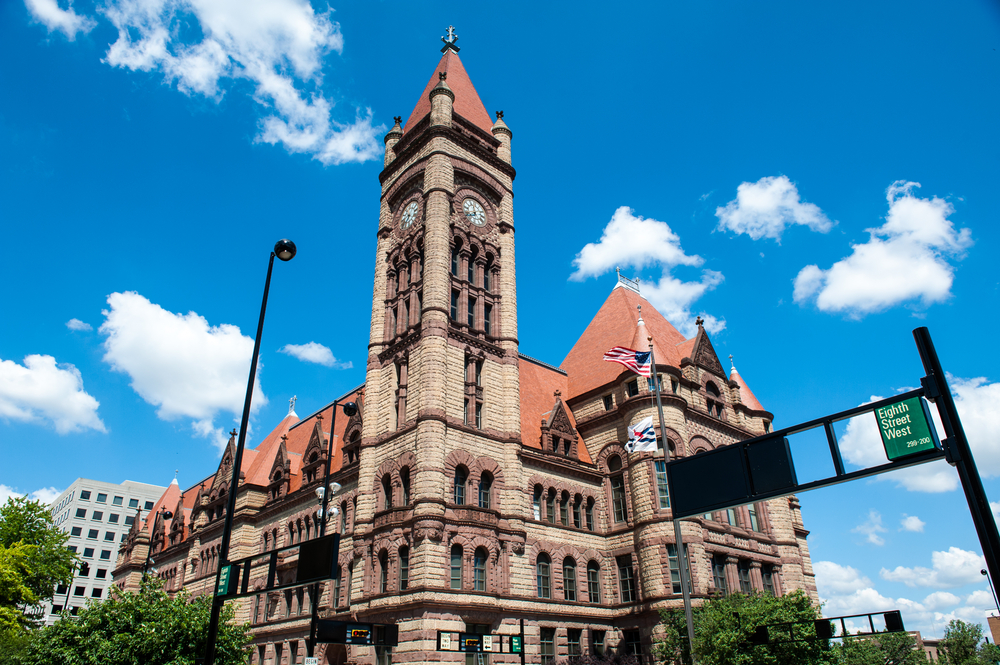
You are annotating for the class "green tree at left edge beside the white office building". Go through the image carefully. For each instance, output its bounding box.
[0,497,77,602]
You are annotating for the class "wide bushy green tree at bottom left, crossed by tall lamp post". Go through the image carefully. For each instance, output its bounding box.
[20,578,253,665]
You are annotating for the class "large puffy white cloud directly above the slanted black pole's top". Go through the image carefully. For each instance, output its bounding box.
[794,180,972,318]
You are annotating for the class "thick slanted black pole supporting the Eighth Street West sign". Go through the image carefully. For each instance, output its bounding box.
[913,327,1000,578]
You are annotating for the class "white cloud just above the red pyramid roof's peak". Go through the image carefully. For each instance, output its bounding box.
[569,206,726,337]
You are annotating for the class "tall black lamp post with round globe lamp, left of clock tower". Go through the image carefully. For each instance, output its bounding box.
[205,239,295,665]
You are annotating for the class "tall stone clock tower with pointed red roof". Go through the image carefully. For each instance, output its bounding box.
[353,24,528,657]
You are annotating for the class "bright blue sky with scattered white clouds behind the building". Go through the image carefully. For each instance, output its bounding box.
[0,0,1000,635]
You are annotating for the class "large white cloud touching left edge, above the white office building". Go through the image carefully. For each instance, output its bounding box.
[0,354,107,434]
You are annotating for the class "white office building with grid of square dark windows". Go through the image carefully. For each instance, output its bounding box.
[44,478,166,625]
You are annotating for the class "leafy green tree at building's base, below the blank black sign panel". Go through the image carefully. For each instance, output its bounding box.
[656,591,836,665]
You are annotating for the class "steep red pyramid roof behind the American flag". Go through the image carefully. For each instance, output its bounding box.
[560,287,687,397]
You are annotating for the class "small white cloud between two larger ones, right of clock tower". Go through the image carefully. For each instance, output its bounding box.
[715,175,834,241]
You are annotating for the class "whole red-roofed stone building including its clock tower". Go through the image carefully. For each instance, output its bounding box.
[115,39,817,665]
